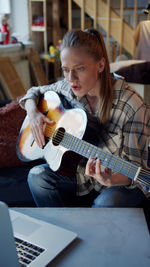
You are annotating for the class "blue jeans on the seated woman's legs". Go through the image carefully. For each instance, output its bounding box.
[28,164,146,208]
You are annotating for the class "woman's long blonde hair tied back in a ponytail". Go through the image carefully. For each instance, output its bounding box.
[60,29,113,124]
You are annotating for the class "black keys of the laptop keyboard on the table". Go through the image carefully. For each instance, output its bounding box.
[15,237,45,267]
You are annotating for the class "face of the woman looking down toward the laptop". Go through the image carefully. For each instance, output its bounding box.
[61,48,105,98]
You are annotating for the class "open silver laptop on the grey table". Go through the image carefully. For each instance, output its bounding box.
[0,202,77,267]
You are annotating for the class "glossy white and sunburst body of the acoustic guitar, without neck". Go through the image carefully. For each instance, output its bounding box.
[17,91,87,171]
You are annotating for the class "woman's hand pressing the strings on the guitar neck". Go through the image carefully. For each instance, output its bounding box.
[85,158,112,186]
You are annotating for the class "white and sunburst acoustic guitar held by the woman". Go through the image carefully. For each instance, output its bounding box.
[17,91,150,188]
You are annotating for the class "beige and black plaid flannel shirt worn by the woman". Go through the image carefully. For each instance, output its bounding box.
[20,75,150,196]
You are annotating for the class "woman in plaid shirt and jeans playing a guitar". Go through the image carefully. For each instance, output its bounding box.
[20,29,150,207]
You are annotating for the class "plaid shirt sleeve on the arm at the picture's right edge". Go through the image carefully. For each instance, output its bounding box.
[122,104,150,188]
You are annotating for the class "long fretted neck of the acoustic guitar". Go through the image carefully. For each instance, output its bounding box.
[55,129,150,188]
